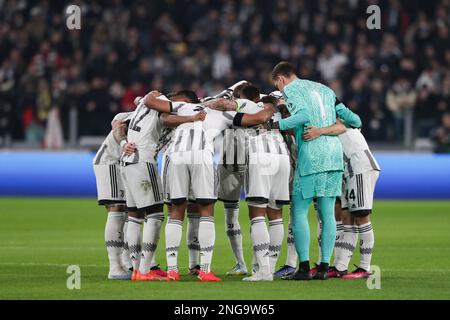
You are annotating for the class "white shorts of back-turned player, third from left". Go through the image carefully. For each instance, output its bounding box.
[168,151,217,204]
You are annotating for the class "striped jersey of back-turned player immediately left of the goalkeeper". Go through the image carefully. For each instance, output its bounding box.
[236,99,289,155]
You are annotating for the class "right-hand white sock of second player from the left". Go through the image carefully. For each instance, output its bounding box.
[139,212,164,274]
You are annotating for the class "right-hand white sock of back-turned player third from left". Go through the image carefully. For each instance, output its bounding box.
[198,217,216,273]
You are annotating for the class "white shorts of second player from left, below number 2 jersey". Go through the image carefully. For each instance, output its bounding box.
[121,162,163,211]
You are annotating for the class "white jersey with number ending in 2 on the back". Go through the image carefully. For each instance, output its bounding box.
[121,100,162,165]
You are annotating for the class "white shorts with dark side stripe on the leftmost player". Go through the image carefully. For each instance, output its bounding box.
[94,164,125,205]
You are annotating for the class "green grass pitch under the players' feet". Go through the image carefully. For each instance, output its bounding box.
[0,198,450,300]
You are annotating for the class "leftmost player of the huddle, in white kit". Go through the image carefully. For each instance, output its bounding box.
[93,112,131,279]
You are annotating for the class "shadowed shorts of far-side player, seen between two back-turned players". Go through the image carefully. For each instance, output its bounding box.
[217,164,246,202]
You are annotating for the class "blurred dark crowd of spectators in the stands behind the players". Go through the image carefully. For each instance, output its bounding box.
[0,0,450,150]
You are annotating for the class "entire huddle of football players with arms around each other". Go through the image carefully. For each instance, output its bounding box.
[93,62,380,282]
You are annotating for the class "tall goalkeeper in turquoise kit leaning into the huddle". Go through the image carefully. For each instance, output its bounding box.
[271,62,361,280]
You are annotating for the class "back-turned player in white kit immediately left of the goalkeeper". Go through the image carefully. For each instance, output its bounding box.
[211,89,290,281]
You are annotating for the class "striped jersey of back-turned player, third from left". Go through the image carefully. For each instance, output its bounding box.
[168,102,236,153]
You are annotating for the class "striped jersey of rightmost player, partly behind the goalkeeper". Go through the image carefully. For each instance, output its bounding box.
[339,128,380,177]
